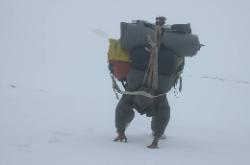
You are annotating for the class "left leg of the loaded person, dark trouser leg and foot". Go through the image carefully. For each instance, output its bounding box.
[115,95,135,142]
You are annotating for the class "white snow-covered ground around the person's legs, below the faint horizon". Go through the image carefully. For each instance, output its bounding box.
[0,78,250,165]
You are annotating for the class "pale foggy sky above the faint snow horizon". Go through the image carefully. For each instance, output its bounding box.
[0,0,250,94]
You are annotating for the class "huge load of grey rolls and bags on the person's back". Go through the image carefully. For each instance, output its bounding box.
[108,17,201,97]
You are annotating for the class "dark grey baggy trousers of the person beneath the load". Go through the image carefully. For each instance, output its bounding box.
[115,95,170,137]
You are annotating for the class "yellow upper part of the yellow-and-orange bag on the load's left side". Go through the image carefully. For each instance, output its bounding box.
[108,38,131,62]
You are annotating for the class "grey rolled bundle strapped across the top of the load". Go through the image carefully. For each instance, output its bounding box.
[120,21,200,57]
